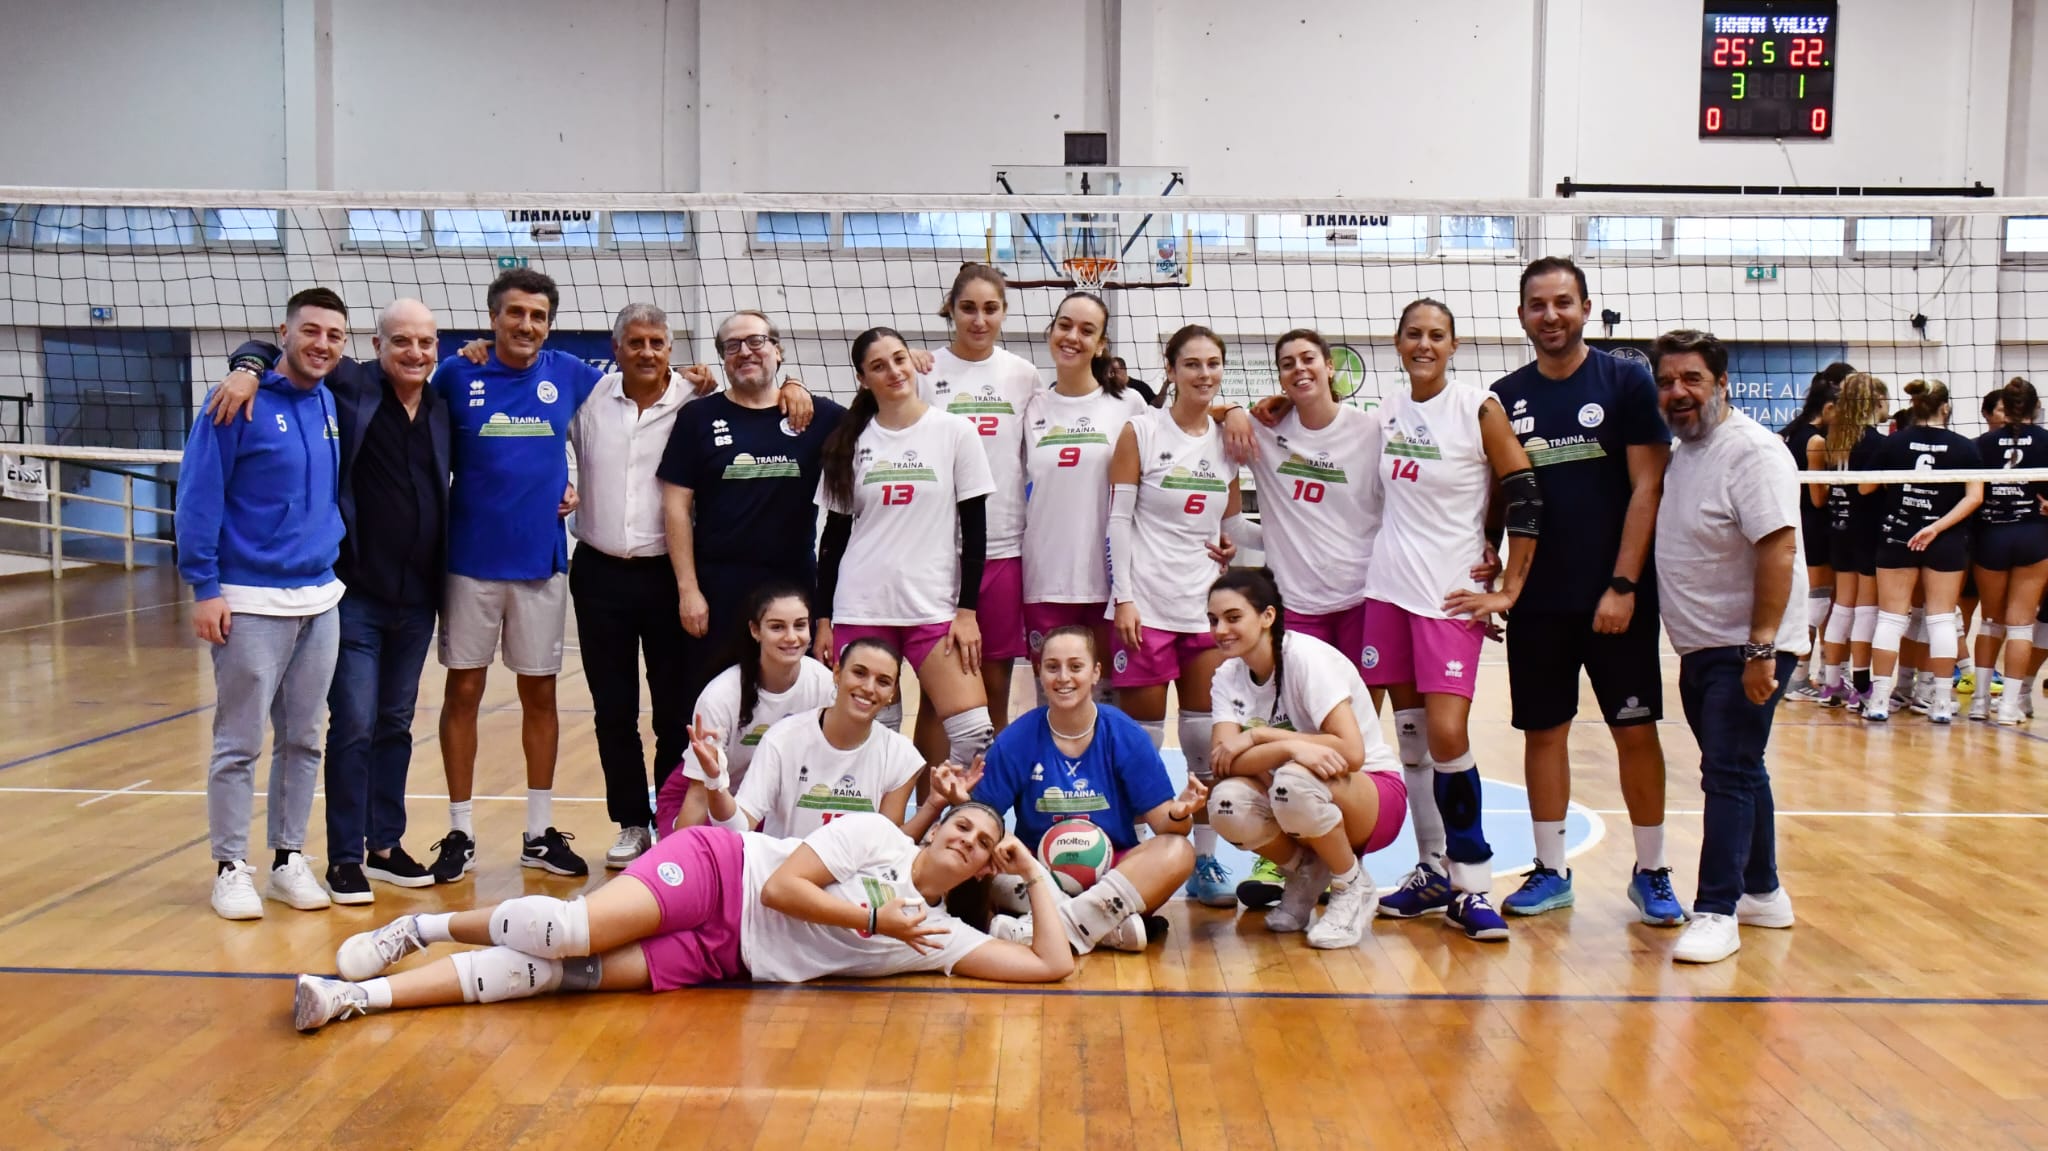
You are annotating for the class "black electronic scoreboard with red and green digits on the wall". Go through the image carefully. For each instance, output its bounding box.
[1700,0,1835,139]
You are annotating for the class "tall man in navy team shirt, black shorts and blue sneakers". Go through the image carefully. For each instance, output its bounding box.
[1493,256,1686,926]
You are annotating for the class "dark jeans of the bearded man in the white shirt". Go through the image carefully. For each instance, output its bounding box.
[1677,647,1798,915]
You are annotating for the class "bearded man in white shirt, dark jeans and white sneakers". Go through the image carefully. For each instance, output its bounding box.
[1651,332,1806,963]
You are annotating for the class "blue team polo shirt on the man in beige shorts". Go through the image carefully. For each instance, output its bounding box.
[432,348,600,580]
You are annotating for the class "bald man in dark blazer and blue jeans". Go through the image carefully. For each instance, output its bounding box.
[207,299,449,903]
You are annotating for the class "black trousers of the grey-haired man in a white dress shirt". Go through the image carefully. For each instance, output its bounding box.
[569,545,696,827]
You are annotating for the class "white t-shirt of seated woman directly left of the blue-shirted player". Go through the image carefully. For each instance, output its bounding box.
[733,711,924,836]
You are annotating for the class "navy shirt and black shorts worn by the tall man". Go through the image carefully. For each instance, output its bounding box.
[1493,348,1671,731]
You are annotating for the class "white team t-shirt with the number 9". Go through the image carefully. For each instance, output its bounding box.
[1024,387,1145,604]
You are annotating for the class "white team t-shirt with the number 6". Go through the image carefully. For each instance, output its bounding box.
[1110,408,1237,635]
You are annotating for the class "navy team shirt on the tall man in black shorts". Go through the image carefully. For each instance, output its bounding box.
[1493,348,1671,612]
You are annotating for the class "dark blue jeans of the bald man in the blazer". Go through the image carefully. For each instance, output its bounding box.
[328,592,434,864]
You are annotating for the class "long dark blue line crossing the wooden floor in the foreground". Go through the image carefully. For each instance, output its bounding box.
[0,967,2048,1008]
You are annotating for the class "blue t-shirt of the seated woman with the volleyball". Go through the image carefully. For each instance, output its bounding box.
[975,705,1174,852]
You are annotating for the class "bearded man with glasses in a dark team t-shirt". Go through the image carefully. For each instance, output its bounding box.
[655,309,846,745]
